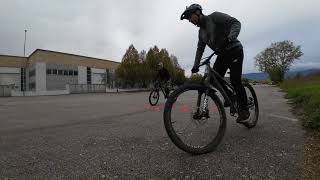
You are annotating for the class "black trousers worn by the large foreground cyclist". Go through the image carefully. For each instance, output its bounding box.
[213,48,247,109]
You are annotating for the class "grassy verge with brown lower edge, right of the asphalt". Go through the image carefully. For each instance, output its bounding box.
[280,73,320,179]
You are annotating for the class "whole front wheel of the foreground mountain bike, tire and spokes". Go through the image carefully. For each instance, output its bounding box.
[164,84,226,154]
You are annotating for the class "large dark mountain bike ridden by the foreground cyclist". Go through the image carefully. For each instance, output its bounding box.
[163,53,259,154]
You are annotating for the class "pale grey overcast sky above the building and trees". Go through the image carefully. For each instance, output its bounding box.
[0,0,320,73]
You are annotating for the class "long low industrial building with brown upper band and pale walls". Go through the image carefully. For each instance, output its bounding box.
[0,49,120,96]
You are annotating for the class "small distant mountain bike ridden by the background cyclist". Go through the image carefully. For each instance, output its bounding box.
[149,81,174,106]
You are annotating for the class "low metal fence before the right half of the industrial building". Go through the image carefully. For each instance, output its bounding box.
[69,84,106,94]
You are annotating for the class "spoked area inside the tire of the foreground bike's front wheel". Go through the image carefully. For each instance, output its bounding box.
[171,89,221,148]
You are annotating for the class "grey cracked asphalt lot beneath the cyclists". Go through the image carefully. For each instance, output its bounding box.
[0,86,306,179]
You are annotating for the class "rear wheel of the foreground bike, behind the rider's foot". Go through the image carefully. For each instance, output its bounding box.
[242,83,259,129]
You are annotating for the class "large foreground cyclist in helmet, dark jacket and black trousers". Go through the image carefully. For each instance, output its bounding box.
[180,4,250,122]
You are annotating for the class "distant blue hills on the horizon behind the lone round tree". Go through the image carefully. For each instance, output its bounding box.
[242,69,320,81]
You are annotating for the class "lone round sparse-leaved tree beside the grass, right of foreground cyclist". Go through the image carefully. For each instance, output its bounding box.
[255,40,303,82]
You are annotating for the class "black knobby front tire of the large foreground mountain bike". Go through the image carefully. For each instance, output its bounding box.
[163,84,227,155]
